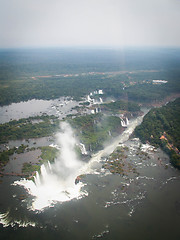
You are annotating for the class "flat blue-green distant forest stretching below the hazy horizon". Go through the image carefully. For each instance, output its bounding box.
[0,49,180,106]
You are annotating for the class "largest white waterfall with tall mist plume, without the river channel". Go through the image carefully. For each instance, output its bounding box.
[15,123,85,210]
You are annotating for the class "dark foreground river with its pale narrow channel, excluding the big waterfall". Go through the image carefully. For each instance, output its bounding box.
[0,113,180,240]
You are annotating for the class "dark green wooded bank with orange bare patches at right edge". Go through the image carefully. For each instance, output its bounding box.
[135,98,180,168]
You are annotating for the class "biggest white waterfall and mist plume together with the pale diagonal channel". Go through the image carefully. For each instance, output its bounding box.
[14,116,143,210]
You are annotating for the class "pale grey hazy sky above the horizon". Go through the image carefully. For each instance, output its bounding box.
[0,0,180,48]
